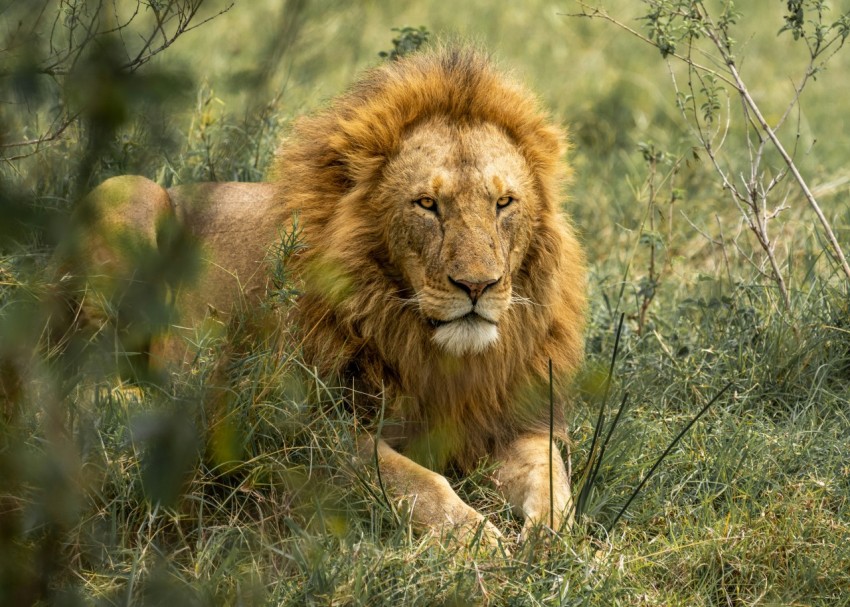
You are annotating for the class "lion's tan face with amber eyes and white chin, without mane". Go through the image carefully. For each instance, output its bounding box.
[380,120,538,356]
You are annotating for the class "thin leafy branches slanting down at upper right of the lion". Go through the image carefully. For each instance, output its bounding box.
[571,0,850,308]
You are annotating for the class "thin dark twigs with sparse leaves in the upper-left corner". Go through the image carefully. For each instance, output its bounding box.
[0,0,233,161]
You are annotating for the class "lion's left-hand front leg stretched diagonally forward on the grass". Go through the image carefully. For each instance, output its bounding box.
[358,437,502,546]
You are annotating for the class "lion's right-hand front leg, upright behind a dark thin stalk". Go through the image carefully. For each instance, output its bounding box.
[486,434,573,535]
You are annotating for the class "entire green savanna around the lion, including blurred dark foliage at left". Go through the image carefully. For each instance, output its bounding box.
[0,0,850,606]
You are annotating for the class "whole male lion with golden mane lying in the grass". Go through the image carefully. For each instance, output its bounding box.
[73,48,585,539]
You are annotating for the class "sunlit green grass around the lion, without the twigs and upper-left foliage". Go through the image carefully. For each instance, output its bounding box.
[0,0,850,606]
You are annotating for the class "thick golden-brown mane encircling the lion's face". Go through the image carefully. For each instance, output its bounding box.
[275,48,585,466]
